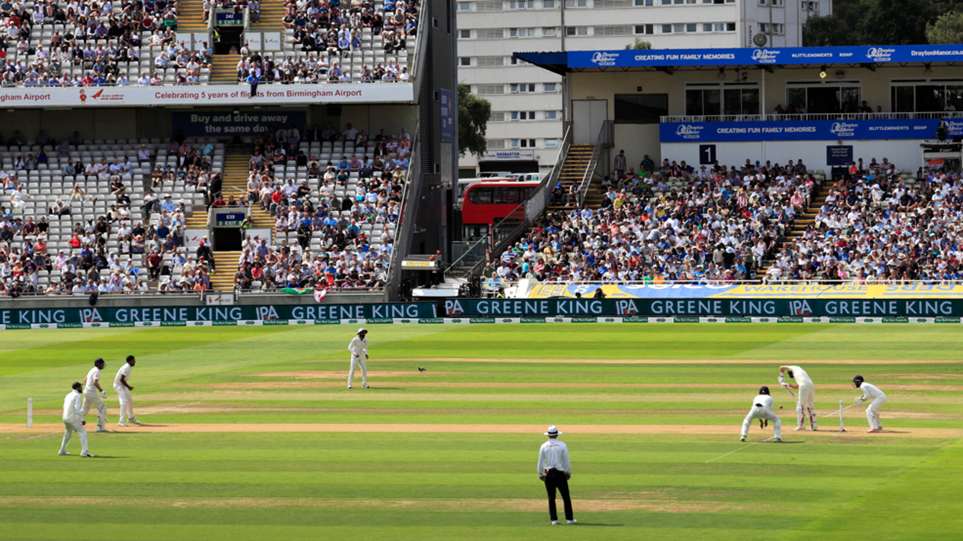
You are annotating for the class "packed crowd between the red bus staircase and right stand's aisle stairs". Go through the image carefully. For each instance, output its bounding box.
[486,157,818,288]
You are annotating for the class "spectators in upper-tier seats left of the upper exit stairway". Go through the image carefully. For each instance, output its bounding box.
[0,0,211,87]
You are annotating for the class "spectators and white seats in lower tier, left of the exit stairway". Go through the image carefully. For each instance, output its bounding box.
[0,132,224,296]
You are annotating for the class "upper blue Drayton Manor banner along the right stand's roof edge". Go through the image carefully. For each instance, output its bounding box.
[568,45,963,68]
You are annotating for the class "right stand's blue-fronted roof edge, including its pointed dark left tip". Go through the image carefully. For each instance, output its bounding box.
[514,45,963,75]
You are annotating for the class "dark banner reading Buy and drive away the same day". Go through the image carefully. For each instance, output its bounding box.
[171,111,307,137]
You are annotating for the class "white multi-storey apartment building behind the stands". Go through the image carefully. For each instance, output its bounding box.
[456,0,832,176]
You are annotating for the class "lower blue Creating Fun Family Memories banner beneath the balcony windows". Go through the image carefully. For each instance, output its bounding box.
[659,118,963,143]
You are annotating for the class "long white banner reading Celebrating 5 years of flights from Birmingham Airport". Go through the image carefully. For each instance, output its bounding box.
[0,83,414,108]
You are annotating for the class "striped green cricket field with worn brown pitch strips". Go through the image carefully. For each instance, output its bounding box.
[0,324,963,541]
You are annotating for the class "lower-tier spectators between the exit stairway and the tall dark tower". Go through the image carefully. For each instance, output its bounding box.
[222,124,411,291]
